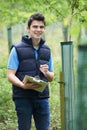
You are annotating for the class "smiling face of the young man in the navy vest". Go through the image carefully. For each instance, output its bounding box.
[28,20,45,39]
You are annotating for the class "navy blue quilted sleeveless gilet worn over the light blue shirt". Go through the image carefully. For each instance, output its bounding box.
[12,36,50,99]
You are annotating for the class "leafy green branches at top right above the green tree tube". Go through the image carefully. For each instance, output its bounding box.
[40,0,87,41]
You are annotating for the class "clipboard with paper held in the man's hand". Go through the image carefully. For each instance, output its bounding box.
[23,75,48,92]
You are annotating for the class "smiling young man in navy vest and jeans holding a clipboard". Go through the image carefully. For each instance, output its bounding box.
[8,13,54,130]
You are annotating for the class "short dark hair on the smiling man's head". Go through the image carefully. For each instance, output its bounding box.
[28,13,46,27]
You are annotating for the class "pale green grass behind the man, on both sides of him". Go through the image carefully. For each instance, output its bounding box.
[0,23,61,130]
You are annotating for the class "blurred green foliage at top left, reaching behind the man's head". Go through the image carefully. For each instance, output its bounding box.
[0,0,55,26]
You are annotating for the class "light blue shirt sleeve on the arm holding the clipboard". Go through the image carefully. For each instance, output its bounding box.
[7,47,19,70]
